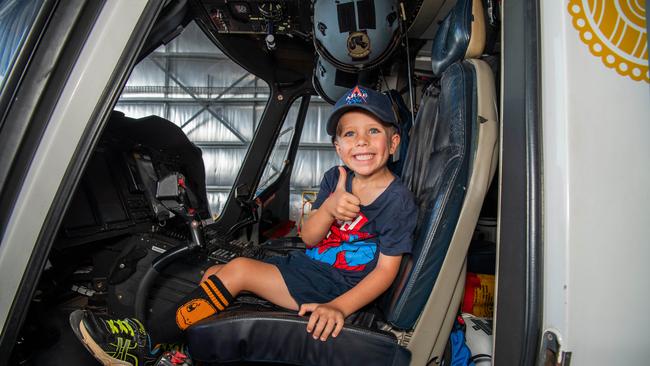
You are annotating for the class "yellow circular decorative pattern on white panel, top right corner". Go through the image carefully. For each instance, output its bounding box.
[568,0,650,83]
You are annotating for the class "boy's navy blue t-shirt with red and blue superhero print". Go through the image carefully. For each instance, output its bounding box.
[305,167,417,282]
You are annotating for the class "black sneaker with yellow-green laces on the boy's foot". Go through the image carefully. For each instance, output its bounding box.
[70,310,156,366]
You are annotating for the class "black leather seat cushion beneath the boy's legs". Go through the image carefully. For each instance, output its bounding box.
[187,311,410,365]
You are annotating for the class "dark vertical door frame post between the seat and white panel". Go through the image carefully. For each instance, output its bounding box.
[493,0,544,365]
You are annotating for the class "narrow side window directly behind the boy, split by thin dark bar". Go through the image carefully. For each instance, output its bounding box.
[258,97,341,223]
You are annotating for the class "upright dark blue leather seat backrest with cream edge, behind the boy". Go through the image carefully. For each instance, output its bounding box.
[384,0,497,357]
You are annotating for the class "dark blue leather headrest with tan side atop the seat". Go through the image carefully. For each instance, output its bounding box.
[431,0,485,77]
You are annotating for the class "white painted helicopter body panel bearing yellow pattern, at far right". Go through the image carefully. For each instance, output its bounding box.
[541,0,650,365]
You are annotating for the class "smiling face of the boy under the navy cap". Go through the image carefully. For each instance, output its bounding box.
[334,110,400,177]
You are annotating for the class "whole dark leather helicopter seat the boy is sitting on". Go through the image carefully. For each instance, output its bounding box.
[187,0,497,365]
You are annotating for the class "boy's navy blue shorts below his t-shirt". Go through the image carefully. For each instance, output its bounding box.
[264,250,354,306]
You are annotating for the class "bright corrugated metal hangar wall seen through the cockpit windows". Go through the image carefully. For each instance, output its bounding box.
[115,22,340,222]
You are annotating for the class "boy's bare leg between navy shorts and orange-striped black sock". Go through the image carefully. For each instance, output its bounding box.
[211,258,298,310]
